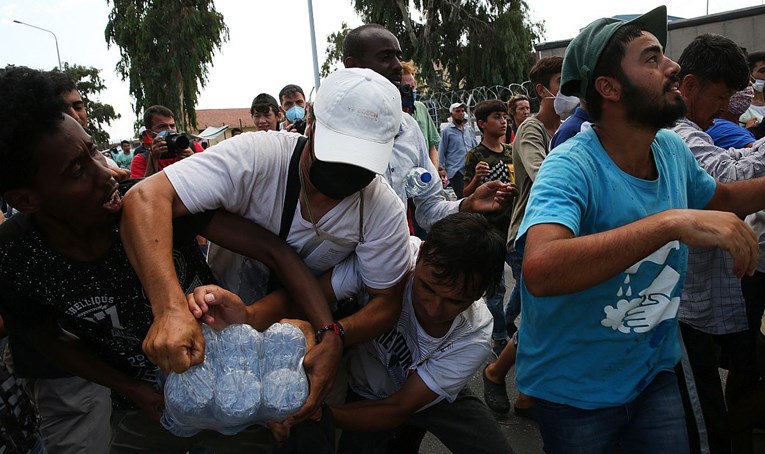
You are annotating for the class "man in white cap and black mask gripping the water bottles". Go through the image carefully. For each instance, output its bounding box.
[122,69,409,426]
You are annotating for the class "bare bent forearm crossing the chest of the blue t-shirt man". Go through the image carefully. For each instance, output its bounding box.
[523,210,759,296]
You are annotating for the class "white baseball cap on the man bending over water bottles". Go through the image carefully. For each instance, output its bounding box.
[313,68,402,173]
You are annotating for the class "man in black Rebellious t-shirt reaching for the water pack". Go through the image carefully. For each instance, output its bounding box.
[0,67,340,452]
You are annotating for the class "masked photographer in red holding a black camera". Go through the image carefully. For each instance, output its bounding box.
[130,105,203,178]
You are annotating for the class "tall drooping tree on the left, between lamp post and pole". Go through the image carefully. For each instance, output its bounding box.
[105,0,228,130]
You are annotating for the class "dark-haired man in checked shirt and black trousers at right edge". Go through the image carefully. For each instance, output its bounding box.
[672,35,765,453]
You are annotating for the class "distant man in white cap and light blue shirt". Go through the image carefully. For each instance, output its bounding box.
[438,102,478,198]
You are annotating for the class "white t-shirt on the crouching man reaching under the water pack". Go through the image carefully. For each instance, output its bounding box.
[332,237,493,411]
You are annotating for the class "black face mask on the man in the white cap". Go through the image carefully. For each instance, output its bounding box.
[308,160,375,200]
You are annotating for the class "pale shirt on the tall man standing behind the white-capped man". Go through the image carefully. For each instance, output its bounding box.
[385,113,460,230]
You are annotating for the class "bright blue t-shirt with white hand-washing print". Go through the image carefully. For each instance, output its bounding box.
[516,129,716,409]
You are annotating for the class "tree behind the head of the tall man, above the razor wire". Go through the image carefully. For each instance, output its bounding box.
[323,0,544,91]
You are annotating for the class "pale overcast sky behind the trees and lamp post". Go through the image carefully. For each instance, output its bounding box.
[0,0,763,141]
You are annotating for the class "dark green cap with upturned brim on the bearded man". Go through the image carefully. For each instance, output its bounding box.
[561,6,667,99]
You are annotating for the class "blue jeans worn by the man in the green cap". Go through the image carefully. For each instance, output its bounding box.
[534,371,689,454]
